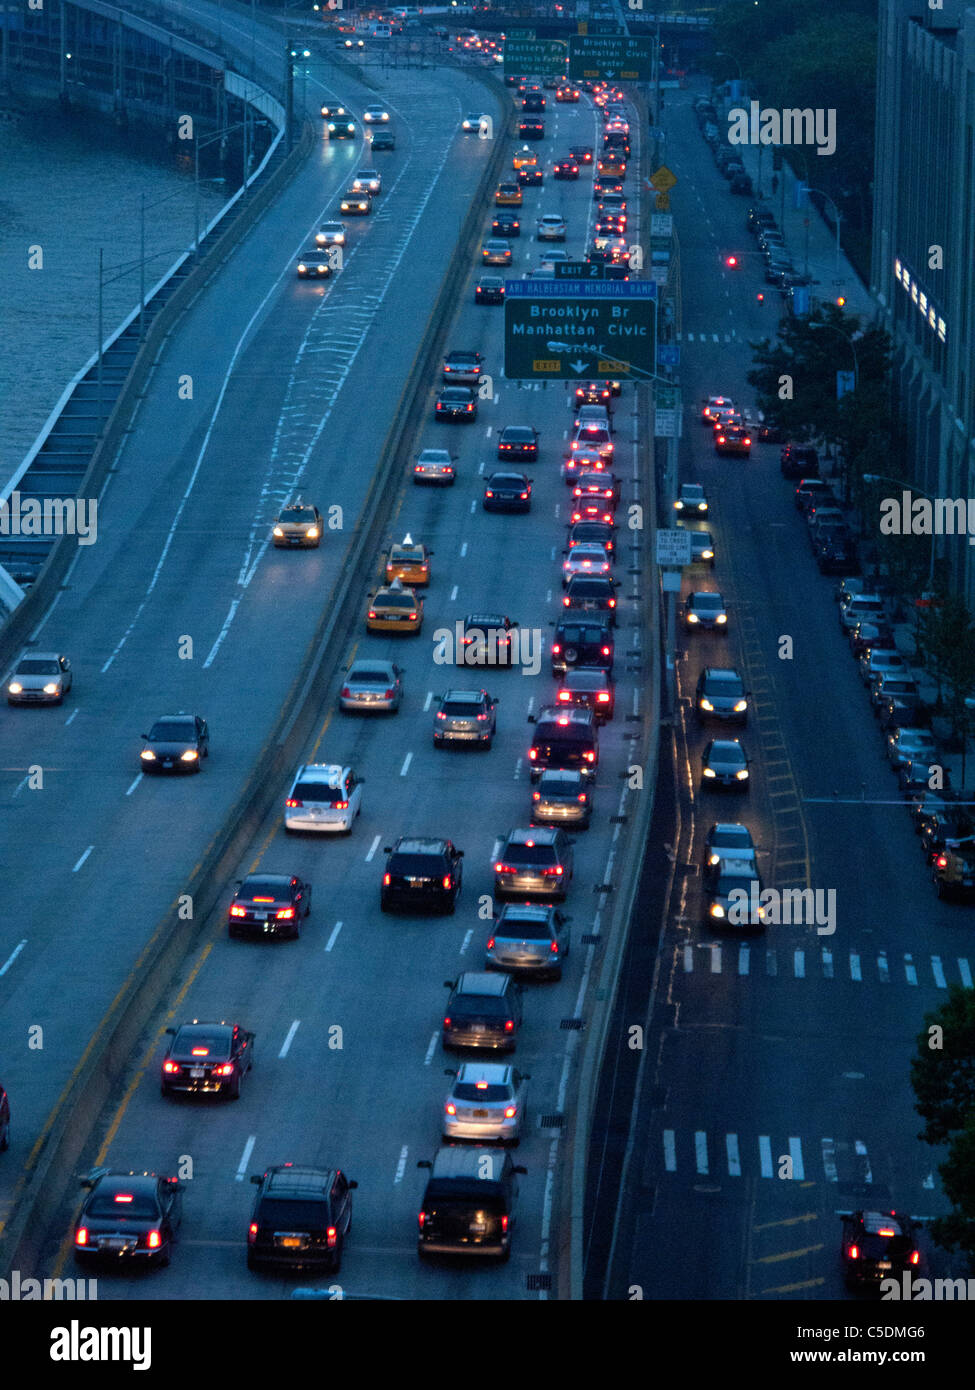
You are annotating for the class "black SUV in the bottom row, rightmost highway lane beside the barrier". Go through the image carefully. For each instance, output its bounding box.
[416,1148,524,1261]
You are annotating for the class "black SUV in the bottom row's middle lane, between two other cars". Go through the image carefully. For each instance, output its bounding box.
[248,1163,357,1272]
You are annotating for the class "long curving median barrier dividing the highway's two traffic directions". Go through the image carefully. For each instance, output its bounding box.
[0,62,514,1277]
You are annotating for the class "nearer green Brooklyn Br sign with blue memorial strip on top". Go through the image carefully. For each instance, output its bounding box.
[505,278,656,381]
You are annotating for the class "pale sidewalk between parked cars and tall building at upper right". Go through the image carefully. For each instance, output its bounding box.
[700,88,876,325]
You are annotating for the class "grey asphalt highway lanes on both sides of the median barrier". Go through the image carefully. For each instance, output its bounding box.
[0,43,652,1298]
